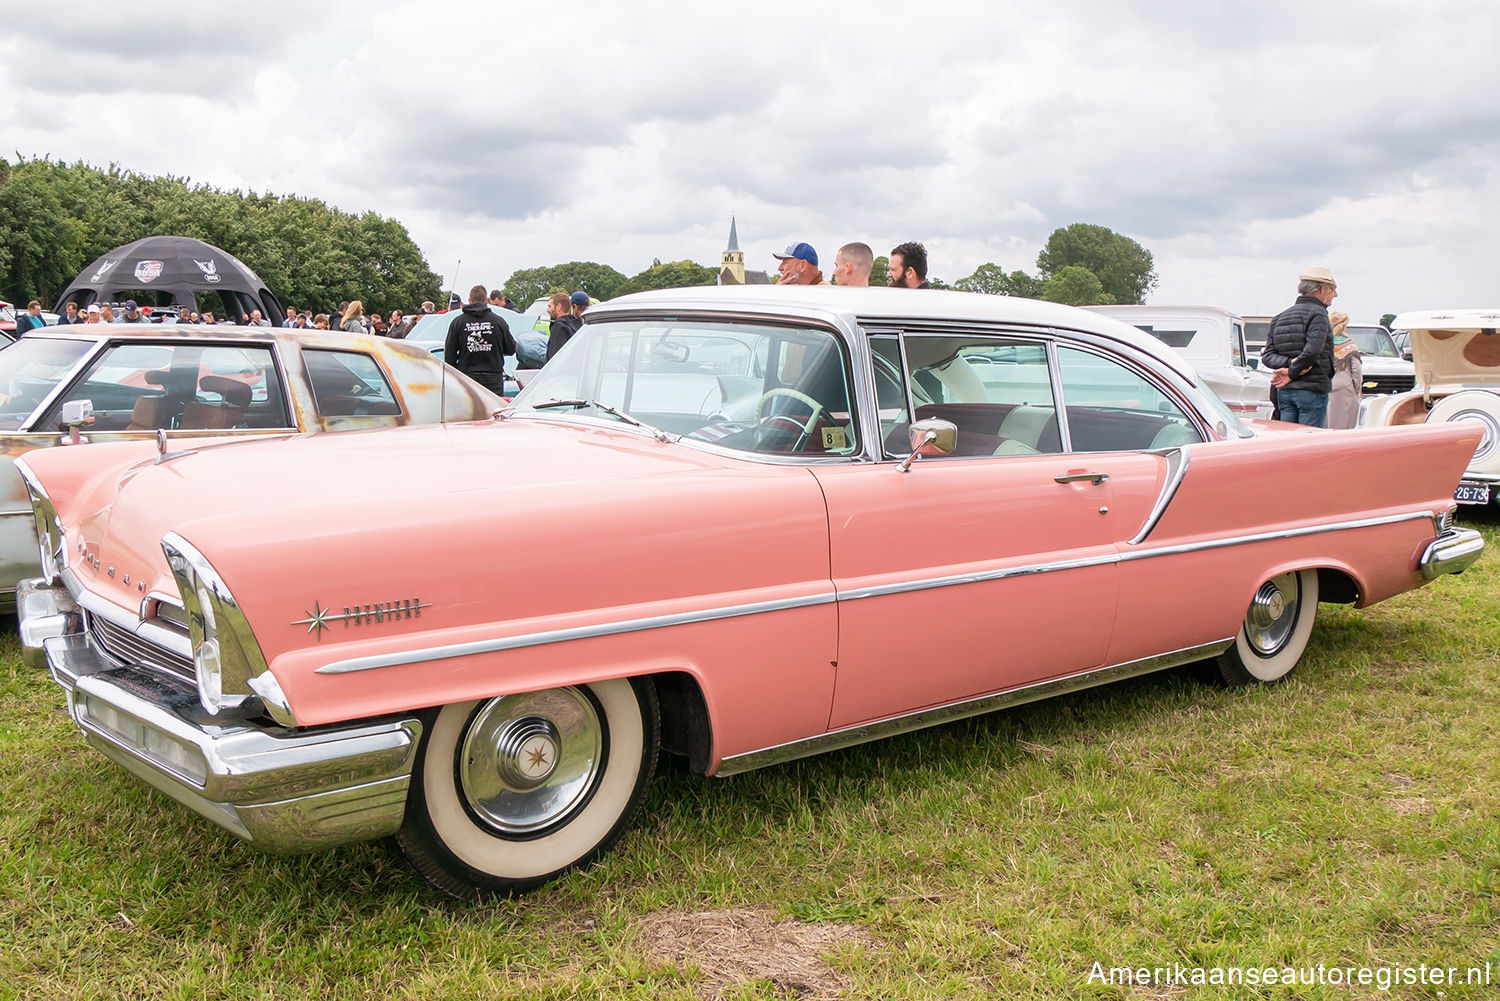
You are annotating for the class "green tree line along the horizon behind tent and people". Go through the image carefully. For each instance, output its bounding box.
[0,158,1157,312]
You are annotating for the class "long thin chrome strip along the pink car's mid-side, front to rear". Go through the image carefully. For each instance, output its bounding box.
[317,512,1433,674]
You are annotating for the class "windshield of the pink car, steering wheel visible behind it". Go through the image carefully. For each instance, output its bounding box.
[513,318,858,455]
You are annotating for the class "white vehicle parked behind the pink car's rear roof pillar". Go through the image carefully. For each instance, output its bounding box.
[1089,306,1271,420]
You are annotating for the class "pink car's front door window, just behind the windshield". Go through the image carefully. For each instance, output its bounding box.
[897,335,1062,456]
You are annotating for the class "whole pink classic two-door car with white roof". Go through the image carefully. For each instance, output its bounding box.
[20,287,1482,896]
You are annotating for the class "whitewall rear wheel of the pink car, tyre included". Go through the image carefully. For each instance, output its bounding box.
[1218,570,1317,684]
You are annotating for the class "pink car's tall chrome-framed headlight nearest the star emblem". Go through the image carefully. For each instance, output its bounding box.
[162,533,266,713]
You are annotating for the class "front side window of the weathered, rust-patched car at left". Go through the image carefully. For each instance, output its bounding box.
[48,342,288,431]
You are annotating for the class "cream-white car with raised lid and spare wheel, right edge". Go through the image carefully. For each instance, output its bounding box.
[1361,309,1500,504]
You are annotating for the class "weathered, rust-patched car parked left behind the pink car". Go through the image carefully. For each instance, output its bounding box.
[0,324,504,608]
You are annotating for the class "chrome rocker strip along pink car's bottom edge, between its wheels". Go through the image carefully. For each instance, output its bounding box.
[714,636,1235,777]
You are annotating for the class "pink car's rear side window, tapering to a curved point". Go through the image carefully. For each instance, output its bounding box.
[1058,348,1203,452]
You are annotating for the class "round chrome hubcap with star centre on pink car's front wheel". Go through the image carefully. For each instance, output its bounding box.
[458,689,605,834]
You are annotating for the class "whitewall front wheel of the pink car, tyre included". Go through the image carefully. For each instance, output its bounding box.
[396,680,660,899]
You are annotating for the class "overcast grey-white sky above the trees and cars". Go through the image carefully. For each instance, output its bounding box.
[0,0,1500,323]
